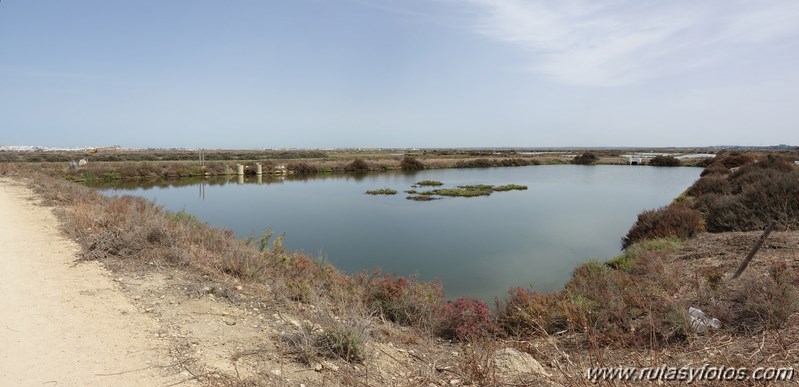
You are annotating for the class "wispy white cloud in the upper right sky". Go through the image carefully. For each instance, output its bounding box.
[461,0,799,86]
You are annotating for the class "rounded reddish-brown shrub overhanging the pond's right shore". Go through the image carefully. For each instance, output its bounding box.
[622,202,704,249]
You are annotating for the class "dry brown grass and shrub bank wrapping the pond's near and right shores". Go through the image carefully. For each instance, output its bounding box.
[0,154,799,385]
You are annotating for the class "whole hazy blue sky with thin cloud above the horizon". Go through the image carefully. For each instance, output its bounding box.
[0,0,799,149]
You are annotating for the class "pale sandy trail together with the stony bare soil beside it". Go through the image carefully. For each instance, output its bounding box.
[0,178,484,386]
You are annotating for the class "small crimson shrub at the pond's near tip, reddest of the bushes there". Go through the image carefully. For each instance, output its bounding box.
[439,297,494,341]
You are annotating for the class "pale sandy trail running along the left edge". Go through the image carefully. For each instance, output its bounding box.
[0,179,184,386]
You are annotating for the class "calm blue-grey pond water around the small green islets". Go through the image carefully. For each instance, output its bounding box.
[98,165,701,301]
